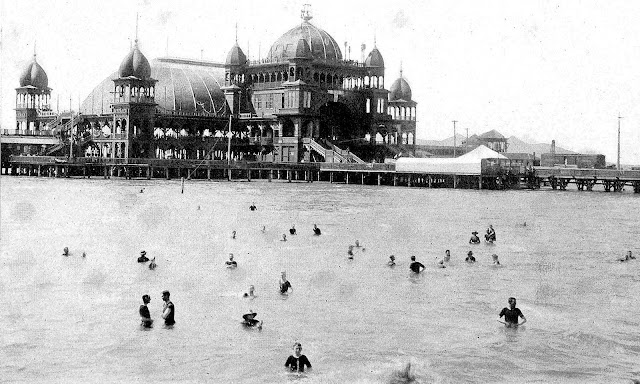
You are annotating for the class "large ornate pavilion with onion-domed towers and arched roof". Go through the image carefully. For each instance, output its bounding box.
[2,8,416,163]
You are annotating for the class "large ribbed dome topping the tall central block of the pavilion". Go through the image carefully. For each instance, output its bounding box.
[267,20,342,61]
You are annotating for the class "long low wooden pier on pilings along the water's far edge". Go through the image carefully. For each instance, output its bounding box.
[0,156,640,193]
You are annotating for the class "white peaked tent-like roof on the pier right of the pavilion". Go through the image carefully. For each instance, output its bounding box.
[396,145,507,175]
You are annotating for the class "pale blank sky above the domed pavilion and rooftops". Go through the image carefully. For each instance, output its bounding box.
[0,0,640,164]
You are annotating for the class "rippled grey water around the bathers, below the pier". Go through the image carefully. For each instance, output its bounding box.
[0,177,640,383]
